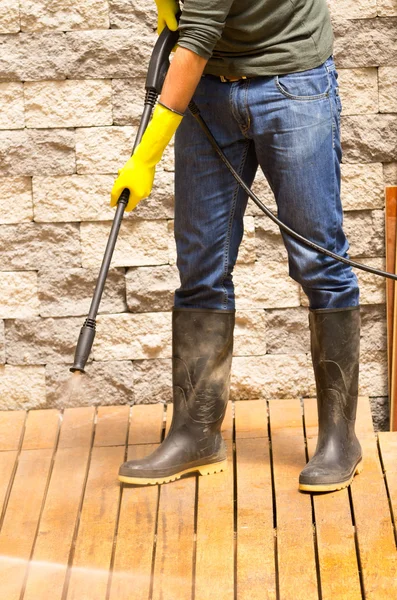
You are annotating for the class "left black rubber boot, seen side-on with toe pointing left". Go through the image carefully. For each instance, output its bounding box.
[119,308,235,485]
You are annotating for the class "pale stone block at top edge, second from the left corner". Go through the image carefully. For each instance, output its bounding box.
[21,0,109,31]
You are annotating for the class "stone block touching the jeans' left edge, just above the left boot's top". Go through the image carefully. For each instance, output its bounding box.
[126,265,180,312]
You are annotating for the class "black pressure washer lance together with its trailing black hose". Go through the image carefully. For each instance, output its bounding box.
[70,27,397,373]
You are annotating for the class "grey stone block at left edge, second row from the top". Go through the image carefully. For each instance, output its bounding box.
[0,32,70,81]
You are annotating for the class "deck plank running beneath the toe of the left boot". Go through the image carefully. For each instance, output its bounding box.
[109,405,163,600]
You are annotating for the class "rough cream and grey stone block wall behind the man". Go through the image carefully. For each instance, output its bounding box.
[0,0,397,426]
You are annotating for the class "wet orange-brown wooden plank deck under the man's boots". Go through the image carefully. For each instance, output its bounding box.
[0,398,397,600]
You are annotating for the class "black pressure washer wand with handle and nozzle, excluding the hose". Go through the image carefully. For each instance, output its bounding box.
[70,27,179,373]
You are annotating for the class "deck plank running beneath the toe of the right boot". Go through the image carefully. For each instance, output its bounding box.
[304,398,362,600]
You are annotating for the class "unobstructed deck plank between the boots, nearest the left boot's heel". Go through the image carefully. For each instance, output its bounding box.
[235,400,276,600]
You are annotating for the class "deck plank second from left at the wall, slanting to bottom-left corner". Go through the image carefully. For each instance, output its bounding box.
[0,410,60,600]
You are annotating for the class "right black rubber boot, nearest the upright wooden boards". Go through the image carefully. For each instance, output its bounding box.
[299,306,362,492]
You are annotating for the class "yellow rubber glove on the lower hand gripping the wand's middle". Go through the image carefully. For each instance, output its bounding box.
[110,104,183,212]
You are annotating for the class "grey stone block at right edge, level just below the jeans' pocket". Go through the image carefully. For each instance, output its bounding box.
[342,115,397,163]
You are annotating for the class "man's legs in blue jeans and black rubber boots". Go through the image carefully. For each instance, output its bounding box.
[118,58,361,491]
